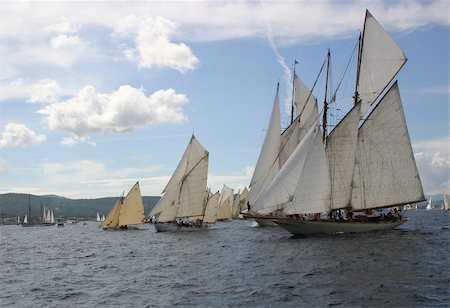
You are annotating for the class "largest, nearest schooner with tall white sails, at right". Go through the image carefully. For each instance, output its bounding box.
[244,11,424,234]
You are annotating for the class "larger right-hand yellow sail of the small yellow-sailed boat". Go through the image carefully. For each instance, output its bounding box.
[118,182,145,226]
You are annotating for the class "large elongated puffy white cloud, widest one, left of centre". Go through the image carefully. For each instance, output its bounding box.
[38,85,188,137]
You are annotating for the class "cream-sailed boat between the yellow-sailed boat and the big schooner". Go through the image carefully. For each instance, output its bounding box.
[148,135,219,231]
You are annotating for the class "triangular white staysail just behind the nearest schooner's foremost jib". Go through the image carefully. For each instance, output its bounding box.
[283,122,331,215]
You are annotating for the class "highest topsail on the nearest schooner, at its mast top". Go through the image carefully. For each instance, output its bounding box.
[358,11,407,114]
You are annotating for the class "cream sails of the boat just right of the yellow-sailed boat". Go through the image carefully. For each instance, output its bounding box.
[149,136,209,222]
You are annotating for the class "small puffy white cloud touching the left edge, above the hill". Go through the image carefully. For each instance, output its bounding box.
[0,123,46,147]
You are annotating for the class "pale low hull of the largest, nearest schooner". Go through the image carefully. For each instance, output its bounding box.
[273,218,408,235]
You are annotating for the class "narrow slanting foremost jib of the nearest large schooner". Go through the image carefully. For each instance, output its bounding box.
[255,122,320,214]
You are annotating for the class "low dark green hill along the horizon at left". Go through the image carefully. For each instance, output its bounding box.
[0,193,160,219]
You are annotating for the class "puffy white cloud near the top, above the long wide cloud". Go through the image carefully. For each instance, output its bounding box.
[114,16,199,73]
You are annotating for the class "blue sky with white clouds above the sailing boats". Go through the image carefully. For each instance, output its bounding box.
[0,0,450,198]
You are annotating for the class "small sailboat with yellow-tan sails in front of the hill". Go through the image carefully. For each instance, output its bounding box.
[100,182,145,230]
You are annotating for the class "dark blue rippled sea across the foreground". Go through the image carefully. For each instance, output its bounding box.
[0,210,450,307]
